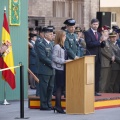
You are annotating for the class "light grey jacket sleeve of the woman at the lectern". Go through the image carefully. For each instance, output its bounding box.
[52,45,65,64]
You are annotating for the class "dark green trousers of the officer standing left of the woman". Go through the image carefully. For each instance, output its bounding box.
[38,75,54,108]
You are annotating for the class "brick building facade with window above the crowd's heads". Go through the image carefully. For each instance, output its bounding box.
[28,0,99,29]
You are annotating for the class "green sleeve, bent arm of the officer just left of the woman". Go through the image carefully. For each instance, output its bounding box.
[36,43,52,67]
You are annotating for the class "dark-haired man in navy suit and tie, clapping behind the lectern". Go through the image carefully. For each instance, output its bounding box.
[85,19,105,96]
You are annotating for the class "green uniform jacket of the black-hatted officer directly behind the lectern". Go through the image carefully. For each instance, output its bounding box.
[64,31,77,59]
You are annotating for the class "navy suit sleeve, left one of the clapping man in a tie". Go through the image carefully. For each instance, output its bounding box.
[85,32,101,48]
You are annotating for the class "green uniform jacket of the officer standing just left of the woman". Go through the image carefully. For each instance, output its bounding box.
[35,39,55,75]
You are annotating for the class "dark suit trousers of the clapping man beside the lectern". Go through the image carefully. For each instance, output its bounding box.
[95,60,101,92]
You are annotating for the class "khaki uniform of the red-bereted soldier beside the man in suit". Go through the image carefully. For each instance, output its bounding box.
[100,40,115,92]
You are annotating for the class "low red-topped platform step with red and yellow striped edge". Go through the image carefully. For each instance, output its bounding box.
[28,93,120,109]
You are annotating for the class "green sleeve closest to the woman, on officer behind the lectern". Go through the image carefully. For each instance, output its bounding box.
[65,38,76,59]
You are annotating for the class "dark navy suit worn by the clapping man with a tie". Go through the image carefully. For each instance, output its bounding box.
[84,28,104,92]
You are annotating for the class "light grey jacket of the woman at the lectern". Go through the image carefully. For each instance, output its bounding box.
[52,44,65,70]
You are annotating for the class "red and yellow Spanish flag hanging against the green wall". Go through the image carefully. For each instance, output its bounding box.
[0,10,16,89]
